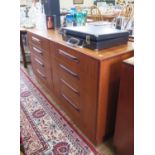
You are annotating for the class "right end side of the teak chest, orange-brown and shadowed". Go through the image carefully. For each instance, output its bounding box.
[96,52,133,143]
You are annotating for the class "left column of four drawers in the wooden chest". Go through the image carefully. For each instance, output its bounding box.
[28,33,51,88]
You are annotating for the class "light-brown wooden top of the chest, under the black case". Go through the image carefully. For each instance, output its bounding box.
[27,29,134,60]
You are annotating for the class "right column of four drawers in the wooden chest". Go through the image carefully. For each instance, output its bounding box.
[53,44,81,119]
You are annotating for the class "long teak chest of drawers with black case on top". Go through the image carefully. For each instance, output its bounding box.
[28,30,133,144]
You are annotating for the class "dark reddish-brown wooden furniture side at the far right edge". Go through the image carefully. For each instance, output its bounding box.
[113,58,134,155]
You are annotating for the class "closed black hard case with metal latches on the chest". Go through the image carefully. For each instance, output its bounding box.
[61,25,129,50]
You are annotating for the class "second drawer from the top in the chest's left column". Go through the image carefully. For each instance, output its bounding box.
[29,44,49,59]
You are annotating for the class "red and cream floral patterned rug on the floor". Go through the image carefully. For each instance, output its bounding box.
[20,70,99,155]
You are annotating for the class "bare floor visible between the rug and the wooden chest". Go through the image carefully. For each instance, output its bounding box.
[21,64,115,155]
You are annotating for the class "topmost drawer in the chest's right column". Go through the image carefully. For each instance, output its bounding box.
[54,44,80,72]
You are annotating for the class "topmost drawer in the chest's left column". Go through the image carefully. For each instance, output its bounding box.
[28,32,50,51]
